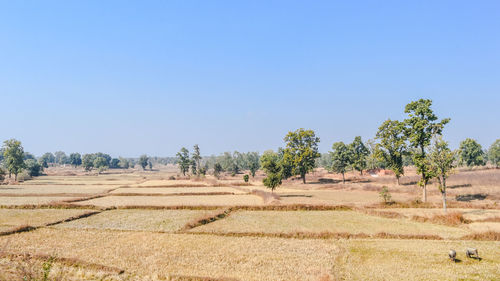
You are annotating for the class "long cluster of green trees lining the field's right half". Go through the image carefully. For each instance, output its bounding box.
[261,99,500,210]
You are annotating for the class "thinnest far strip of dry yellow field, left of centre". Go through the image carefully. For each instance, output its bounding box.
[111,186,246,194]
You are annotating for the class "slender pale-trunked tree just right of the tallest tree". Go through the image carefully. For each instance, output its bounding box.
[429,137,455,212]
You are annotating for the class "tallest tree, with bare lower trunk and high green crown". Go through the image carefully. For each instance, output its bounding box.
[404,99,450,202]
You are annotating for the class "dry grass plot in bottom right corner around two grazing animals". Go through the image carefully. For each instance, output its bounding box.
[334,239,500,280]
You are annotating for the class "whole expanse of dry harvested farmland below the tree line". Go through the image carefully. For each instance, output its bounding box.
[0,166,500,281]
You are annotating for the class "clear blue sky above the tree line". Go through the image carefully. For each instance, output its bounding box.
[0,0,500,156]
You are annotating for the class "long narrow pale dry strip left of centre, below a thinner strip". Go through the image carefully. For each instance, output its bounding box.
[76,195,263,207]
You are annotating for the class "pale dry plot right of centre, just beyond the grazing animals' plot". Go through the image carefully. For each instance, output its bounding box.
[191,211,470,238]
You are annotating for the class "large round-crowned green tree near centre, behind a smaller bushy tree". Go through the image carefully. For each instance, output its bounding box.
[284,128,321,183]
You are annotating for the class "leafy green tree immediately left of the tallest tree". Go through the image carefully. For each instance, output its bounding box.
[375,119,407,185]
